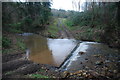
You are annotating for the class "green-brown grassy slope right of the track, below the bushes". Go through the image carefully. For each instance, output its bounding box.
[63,18,104,42]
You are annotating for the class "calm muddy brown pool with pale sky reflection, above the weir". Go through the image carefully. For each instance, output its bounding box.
[25,35,77,67]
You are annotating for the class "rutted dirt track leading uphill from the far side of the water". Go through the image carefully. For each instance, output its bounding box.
[57,19,74,39]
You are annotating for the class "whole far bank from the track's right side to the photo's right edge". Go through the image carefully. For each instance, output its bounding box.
[63,19,120,48]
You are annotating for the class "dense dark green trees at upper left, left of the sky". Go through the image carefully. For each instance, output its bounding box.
[2,2,51,32]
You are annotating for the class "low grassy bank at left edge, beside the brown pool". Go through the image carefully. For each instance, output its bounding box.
[2,33,26,54]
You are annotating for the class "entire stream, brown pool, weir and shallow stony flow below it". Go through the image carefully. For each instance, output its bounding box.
[25,34,120,74]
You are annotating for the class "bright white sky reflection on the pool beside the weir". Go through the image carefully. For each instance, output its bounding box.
[48,39,76,65]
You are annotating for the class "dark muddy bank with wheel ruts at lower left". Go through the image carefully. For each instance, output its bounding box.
[2,53,59,78]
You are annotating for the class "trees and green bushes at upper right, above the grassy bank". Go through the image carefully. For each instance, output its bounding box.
[68,2,120,47]
